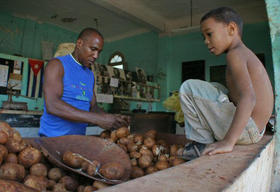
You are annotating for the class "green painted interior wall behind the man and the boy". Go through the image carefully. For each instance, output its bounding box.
[0,13,274,111]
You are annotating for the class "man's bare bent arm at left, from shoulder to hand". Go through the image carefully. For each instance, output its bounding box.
[43,59,127,129]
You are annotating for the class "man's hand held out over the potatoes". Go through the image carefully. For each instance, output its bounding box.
[98,113,129,130]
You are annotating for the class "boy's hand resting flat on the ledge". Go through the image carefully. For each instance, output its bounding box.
[202,140,234,155]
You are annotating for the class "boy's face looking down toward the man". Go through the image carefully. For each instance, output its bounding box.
[201,18,231,55]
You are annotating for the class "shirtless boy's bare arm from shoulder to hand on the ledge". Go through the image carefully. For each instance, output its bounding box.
[203,51,256,155]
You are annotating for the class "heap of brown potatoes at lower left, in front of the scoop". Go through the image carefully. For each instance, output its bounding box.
[0,122,108,192]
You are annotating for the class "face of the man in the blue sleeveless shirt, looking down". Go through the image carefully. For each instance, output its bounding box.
[77,33,104,67]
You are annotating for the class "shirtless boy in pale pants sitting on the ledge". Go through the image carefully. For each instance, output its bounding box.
[178,7,274,159]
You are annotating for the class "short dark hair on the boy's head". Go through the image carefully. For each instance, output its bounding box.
[200,7,243,37]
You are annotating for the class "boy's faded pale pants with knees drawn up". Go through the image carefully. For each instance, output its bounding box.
[180,80,265,144]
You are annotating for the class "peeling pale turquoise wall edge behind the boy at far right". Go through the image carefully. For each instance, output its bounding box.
[265,0,280,192]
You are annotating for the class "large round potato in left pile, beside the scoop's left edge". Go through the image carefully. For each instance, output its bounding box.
[18,146,42,167]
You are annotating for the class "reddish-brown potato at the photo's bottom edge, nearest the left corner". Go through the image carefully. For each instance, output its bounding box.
[24,175,48,191]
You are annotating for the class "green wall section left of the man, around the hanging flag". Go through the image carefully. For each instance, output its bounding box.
[0,12,78,110]
